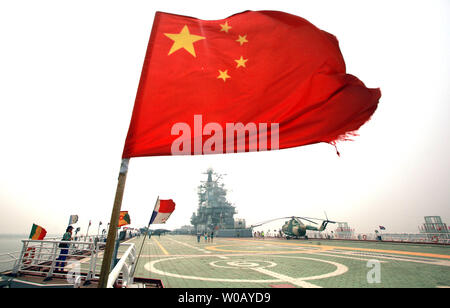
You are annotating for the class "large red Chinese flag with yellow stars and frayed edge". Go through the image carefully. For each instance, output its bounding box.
[123,11,381,158]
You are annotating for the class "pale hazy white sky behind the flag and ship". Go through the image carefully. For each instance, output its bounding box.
[0,0,450,234]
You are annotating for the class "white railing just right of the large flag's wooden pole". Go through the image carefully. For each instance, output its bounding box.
[106,243,136,288]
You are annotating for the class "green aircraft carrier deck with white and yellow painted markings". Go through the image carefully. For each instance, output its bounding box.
[128,235,450,288]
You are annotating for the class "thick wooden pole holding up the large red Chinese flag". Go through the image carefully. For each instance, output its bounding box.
[98,158,130,288]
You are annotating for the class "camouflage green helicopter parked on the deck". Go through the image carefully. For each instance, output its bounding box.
[250,213,336,240]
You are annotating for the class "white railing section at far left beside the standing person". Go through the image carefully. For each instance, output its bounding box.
[12,240,105,286]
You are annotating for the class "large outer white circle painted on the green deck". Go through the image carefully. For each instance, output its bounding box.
[144,256,348,288]
